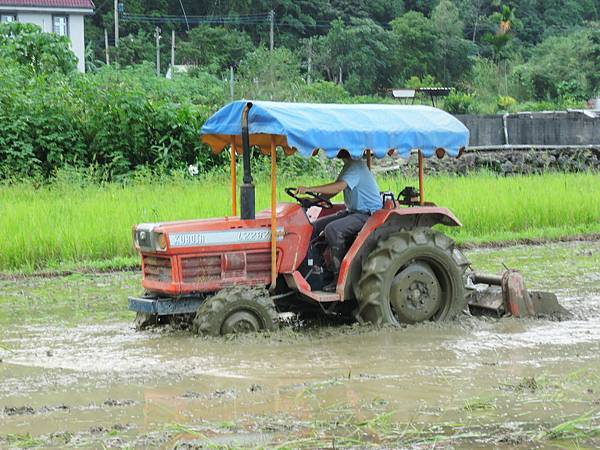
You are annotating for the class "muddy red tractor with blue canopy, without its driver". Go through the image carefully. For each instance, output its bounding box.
[129,101,564,335]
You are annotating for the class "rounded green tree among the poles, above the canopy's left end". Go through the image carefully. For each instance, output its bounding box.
[177,25,254,73]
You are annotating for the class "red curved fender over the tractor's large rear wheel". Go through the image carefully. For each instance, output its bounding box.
[337,206,462,300]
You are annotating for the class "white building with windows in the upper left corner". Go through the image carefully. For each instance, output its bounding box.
[0,0,94,72]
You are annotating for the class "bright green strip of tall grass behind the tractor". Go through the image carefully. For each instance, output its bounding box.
[0,174,600,272]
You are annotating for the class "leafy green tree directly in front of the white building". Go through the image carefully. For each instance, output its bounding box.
[0,22,77,74]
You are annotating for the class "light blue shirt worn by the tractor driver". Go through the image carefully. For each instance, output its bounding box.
[338,159,381,213]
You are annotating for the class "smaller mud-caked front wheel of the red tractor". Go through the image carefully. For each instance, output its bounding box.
[192,286,279,336]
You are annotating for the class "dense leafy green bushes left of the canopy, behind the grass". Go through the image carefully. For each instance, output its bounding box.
[0,64,229,179]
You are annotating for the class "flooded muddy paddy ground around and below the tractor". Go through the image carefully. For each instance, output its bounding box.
[0,242,600,448]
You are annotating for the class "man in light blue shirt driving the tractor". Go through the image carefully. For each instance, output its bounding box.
[297,150,381,292]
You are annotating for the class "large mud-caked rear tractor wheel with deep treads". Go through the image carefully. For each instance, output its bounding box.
[355,228,469,325]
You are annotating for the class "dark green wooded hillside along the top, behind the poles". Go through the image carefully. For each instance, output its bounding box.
[88,0,600,102]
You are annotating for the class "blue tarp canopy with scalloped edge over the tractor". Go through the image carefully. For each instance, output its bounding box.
[201,100,469,158]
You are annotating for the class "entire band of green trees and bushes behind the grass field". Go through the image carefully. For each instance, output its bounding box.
[0,0,600,179]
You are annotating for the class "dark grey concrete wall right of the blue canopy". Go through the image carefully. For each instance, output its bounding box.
[456,111,600,147]
